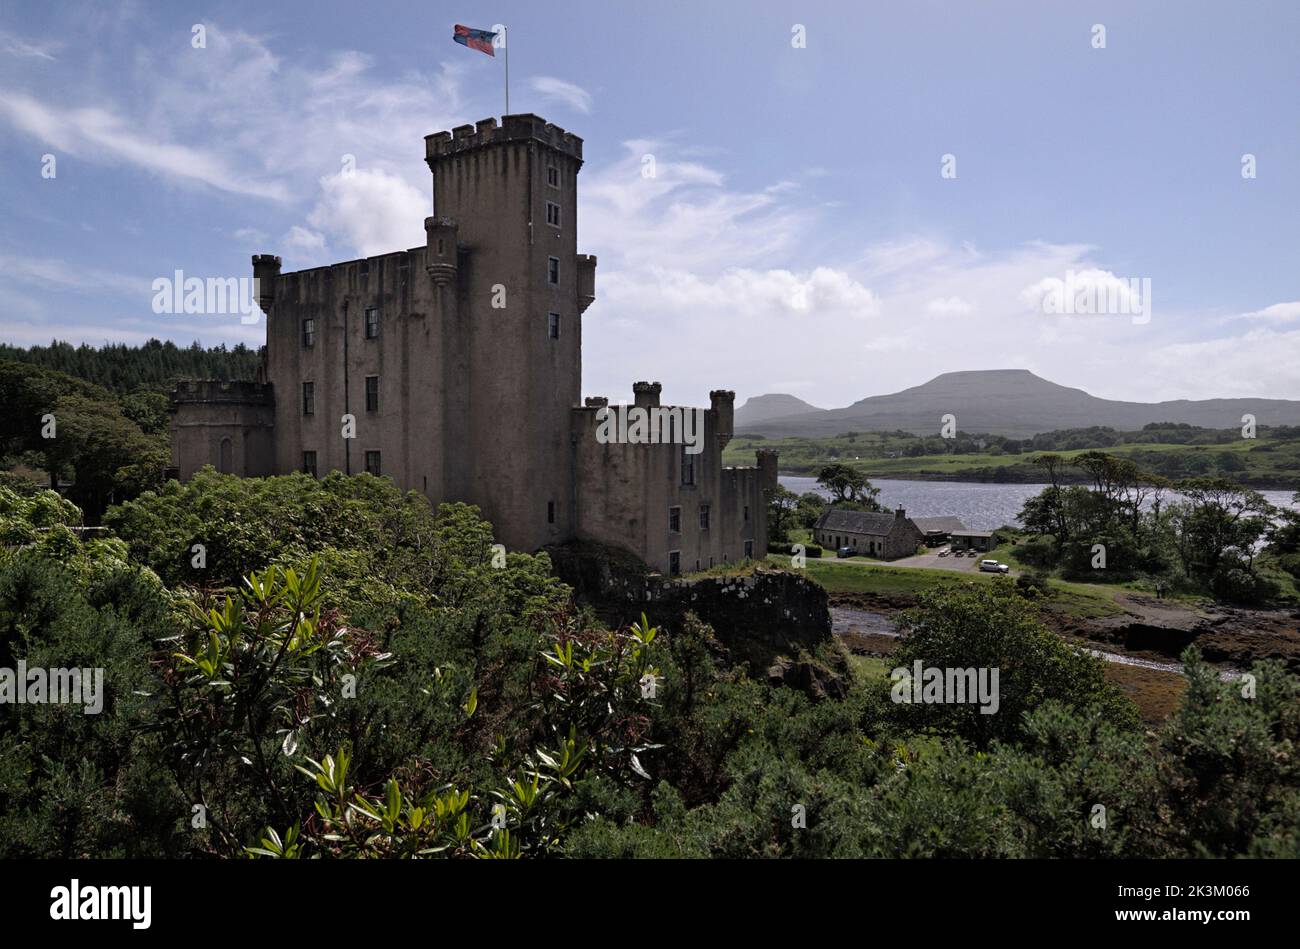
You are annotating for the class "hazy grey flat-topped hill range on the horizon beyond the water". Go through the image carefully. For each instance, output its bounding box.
[736,369,1300,438]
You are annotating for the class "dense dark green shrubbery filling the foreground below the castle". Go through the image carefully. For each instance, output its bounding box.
[0,475,1300,858]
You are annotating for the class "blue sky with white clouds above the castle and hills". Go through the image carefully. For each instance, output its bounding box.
[0,0,1300,406]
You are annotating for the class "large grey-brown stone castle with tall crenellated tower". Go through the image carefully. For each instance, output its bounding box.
[172,114,777,575]
